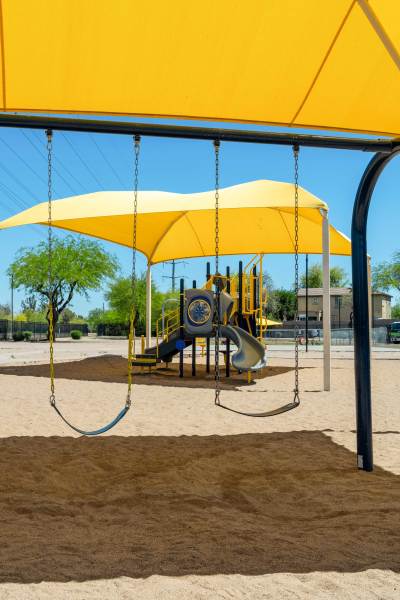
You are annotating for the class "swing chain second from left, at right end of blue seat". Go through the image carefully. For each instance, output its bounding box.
[125,135,140,409]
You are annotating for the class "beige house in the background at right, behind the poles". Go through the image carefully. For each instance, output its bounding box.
[299,288,392,327]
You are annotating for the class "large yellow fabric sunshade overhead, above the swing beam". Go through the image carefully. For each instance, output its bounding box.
[0,0,400,135]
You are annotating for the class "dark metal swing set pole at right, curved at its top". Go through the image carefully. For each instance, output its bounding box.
[351,149,399,471]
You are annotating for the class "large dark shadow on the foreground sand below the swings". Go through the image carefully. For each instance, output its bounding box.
[0,431,400,582]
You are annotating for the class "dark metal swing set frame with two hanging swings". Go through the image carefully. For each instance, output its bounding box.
[0,114,400,471]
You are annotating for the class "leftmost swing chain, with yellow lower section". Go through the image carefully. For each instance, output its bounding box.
[46,129,56,406]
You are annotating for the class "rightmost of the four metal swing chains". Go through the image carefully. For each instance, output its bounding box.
[293,144,300,404]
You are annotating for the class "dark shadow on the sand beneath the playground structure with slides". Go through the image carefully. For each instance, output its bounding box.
[0,355,300,389]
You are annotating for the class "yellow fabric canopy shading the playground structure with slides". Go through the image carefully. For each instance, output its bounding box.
[0,180,351,264]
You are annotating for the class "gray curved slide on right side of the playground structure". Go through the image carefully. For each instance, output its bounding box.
[221,325,267,371]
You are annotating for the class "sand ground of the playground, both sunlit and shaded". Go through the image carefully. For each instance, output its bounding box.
[0,340,400,600]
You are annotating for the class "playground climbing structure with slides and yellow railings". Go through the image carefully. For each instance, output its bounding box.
[139,255,267,382]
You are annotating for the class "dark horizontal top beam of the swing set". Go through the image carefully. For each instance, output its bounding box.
[0,114,400,153]
